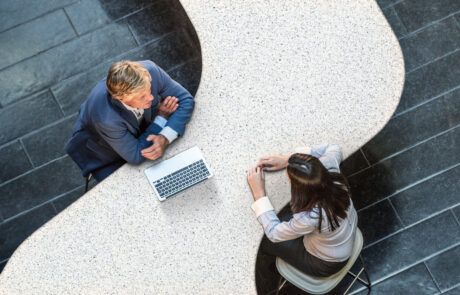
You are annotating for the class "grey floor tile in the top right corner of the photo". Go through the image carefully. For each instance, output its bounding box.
[394,0,460,32]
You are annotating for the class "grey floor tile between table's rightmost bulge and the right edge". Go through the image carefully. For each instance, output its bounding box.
[395,50,460,114]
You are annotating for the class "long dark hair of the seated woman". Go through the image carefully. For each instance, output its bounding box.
[287,153,350,232]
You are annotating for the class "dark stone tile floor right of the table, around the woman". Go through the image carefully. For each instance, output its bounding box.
[256,0,460,295]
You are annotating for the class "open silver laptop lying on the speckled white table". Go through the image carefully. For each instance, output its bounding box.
[145,147,212,201]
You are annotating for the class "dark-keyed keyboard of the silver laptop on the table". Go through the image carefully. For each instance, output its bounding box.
[153,160,211,198]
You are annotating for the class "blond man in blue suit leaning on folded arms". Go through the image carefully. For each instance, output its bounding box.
[66,60,194,181]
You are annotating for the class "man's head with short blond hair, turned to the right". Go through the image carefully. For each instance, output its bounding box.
[106,60,153,109]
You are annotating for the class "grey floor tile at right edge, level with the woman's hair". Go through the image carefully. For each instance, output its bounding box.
[390,166,460,225]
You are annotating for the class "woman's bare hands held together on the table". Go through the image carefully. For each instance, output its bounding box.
[248,155,289,201]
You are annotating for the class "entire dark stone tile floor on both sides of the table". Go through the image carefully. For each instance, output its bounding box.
[0,0,460,295]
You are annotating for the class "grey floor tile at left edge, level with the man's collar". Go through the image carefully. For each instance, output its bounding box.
[0,91,62,144]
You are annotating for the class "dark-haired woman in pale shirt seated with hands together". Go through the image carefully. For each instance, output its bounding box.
[248,144,358,277]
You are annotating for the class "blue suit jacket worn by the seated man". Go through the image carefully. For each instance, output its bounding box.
[66,60,194,181]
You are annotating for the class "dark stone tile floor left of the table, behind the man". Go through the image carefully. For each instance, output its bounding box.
[0,0,201,271]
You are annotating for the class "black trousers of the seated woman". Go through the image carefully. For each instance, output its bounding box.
[259,205,347,277]
